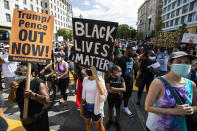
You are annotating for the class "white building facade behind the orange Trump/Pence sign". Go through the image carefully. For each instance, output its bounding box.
[0,0,73,39]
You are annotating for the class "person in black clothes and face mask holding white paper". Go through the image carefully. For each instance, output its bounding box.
[136,50,159,105]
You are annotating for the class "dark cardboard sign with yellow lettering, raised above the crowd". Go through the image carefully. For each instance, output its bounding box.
[156,32,176,48]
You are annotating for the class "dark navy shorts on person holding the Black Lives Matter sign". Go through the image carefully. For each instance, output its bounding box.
[83,104,102,122]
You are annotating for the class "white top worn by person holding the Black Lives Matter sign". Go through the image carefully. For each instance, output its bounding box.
[82,77,105,104]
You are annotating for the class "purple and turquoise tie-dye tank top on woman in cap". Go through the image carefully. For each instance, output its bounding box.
[146,79,193,131]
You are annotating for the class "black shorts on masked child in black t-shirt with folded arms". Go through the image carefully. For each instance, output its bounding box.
[107,96,122,108]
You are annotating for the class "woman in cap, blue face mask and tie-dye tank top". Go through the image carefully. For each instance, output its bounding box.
[145,51,197,131]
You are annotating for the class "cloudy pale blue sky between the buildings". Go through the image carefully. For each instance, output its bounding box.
[69,0,145,28]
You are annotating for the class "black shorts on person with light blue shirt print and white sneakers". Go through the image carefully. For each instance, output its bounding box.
[123,77,133,99]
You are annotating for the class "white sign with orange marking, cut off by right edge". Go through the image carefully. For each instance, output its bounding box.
[181,33,197,44]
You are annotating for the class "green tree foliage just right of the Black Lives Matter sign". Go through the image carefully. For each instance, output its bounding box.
[117,24,136,39]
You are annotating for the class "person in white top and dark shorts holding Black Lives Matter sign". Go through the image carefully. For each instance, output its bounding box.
[80,66,107,131]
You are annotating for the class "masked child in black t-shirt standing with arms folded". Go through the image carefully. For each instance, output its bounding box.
[106,65,126,131]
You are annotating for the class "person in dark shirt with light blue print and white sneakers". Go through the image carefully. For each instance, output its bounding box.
[117,43,135,117]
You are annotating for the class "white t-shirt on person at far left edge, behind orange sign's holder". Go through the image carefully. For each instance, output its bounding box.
[2,54,18,77]
